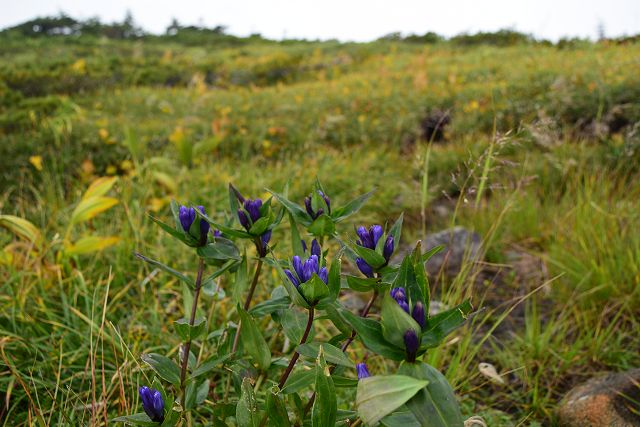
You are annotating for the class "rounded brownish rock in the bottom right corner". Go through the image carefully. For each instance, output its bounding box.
[558,369,640,427]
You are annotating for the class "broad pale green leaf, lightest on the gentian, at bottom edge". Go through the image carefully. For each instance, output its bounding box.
[356,375,428,425]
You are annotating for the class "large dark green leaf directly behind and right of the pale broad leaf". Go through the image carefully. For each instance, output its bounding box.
[398,363,464,427]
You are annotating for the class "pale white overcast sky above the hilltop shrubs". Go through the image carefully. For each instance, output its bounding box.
[0,0,640,41]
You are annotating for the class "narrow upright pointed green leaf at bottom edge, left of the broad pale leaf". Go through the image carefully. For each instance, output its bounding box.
[311,346,338,427]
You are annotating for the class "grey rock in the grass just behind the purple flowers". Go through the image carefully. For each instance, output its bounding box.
[422,227,482,277]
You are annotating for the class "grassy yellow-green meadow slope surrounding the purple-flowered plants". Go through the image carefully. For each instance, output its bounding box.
[0,27,640,426]
